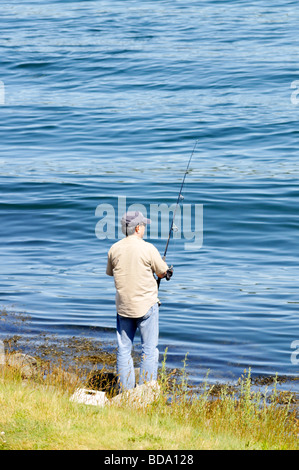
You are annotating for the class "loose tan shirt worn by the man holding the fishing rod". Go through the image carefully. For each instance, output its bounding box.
[106,235,168,318]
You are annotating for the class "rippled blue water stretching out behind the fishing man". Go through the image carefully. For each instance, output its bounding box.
[0,0,299,388]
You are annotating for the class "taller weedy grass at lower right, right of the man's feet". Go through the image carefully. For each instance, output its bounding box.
[159,362,299,449]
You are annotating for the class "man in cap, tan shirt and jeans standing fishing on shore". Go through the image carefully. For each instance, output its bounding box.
[106,211,173,391]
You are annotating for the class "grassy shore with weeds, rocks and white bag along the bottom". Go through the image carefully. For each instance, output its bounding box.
[0,334,299,451]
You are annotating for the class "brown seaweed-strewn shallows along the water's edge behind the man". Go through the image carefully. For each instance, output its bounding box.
[3,333,299,413]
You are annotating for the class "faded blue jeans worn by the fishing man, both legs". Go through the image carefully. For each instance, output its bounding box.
[116,303,159,391]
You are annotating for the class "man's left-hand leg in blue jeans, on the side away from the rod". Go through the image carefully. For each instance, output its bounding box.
[116,315,137,391]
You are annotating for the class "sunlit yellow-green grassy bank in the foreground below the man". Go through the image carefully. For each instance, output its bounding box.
[0,358,299,450]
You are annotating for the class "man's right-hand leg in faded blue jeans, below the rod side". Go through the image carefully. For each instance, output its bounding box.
[138,304,159,385]
